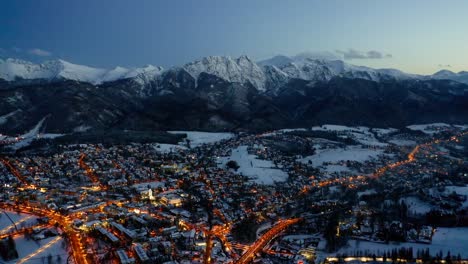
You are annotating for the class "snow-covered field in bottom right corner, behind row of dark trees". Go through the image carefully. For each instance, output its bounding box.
[330,228,468,259]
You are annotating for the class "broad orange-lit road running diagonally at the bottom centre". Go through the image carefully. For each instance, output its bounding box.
[236,218,302,264]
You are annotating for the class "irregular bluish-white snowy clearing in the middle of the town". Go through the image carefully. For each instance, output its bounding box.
[218,146,288,185]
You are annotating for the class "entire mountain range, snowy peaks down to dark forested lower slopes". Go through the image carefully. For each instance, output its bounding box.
[0,56,468,133]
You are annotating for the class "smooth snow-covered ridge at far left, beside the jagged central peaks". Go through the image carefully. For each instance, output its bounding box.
[0,59,162,84]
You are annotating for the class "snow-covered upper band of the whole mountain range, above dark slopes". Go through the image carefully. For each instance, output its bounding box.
[0,55,468,93]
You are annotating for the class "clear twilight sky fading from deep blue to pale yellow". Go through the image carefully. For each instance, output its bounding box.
[0,0,468,74]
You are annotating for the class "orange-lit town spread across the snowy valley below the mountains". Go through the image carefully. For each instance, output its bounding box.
[0,124,468,264]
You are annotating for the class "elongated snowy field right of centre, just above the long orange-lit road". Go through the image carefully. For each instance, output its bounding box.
[299,146,383,166]
